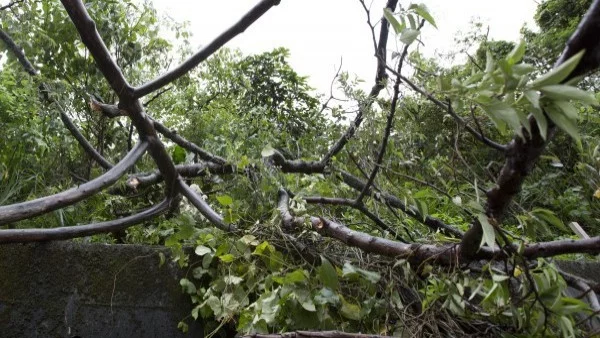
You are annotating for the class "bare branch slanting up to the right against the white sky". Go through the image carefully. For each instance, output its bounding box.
[133,0,280,98]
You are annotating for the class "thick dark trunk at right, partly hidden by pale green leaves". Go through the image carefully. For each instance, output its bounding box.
[461,0,600,257]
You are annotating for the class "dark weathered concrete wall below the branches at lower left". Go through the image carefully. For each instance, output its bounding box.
[0,242,202,338]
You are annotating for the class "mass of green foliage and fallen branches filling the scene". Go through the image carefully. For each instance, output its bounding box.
[0,0,600,337]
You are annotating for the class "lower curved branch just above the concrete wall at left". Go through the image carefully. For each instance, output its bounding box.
[0,199,172,244]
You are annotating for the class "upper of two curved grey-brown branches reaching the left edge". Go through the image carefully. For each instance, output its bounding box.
[0,142,148,225]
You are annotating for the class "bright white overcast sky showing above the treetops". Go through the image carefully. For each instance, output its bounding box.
[154,0,537,93]
